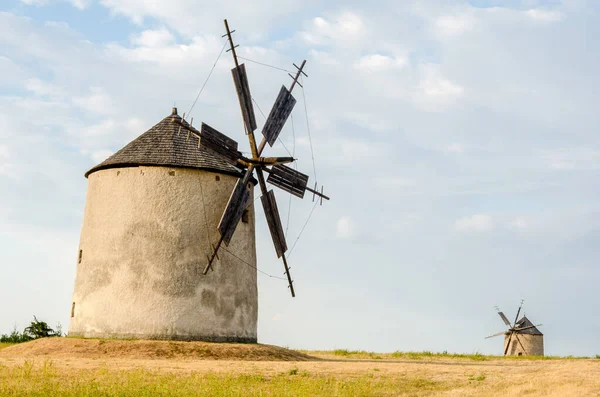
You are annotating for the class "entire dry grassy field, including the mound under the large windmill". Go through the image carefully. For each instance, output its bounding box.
[0,338,600,396]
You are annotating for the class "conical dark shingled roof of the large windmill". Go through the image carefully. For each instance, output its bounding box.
[85,108,242,178]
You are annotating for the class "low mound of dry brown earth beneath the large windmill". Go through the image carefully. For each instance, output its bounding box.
[0,338,319,361]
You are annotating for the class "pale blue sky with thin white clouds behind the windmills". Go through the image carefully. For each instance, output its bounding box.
[0,0,600,356]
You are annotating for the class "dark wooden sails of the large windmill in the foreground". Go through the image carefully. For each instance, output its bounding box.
[200,20,329,297]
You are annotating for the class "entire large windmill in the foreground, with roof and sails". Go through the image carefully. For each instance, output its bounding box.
[69,21,329,342]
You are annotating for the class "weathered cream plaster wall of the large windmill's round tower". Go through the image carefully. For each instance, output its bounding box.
[69,167,258,342]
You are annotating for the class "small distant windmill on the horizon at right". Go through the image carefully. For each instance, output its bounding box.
[485,300,544,356]
